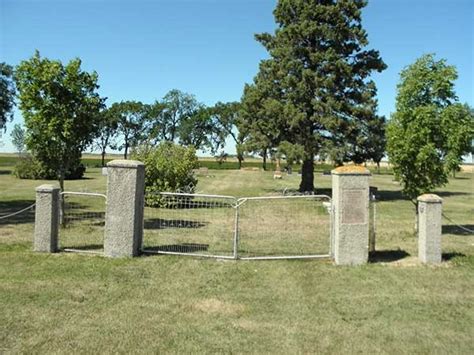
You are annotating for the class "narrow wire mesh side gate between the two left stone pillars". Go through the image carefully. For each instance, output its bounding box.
[59,192,107,254]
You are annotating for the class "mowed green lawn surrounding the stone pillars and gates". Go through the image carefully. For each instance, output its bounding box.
[0,167,474,354]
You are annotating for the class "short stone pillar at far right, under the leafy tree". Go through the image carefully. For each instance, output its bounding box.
[418,194,443,264]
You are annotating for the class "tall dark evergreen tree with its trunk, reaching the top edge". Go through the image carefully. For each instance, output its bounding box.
[243,0,386,191]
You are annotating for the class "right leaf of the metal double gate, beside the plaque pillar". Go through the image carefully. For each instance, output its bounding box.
[238,195,332,259]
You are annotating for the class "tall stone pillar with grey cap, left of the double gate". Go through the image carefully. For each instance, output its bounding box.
[104,160,145,257]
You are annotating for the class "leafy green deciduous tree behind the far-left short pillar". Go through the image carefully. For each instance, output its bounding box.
[15,51,103,189]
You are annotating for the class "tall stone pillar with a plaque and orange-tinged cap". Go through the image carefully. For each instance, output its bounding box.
[332,166,370,265]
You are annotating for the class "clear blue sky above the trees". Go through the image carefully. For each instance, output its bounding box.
[0,0,474,151]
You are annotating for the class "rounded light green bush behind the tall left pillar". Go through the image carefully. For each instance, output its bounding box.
[132,142,199,206]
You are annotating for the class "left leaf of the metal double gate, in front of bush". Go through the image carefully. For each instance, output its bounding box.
[143,192,236,258]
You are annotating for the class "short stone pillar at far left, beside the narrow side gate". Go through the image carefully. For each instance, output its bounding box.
[33,185,60,253]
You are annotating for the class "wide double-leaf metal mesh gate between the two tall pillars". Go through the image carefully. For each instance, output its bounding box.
[143,192,333,260]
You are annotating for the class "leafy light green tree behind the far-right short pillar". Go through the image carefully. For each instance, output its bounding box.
[387,54,474,202]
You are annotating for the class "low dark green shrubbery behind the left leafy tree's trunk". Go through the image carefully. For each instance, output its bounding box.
[13,155,86,180]
